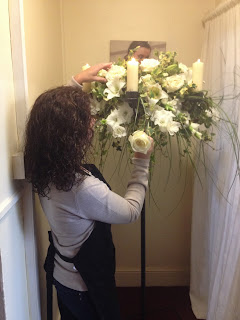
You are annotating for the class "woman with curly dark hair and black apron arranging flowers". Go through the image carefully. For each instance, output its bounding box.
[25,64,152,320]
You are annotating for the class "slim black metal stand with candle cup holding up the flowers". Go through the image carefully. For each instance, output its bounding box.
[126,91,146,320]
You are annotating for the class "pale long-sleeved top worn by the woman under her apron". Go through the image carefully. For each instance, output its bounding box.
[40,158,149,291]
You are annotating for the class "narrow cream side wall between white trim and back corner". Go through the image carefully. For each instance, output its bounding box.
[23,0,63,320]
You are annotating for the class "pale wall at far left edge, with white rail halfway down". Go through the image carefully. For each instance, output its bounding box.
[0,0,29,320]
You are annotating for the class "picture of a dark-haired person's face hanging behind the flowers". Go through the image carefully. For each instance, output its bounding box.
[110,40,166,62]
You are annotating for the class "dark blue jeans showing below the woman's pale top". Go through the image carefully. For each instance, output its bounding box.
[53,279,99,320]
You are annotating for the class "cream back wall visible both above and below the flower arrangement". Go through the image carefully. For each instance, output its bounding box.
[62,0,215,285]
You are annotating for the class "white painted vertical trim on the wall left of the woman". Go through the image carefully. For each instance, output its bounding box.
[9,0,41,320]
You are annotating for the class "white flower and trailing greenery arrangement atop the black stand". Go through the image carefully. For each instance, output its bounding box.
[85,52,220,170]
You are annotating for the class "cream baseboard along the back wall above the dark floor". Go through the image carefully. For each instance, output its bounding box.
[115,268,190,287]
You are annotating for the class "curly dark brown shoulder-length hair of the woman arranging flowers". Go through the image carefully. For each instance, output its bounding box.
[24,86,93,197]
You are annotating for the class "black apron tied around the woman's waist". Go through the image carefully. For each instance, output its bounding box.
[44,165,120,320]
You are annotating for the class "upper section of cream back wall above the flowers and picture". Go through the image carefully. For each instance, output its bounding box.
[63,0,215,80]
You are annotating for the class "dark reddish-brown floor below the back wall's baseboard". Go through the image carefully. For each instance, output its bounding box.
[117,287,204,320]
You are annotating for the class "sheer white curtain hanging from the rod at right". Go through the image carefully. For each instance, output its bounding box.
[190,0,240,320]
